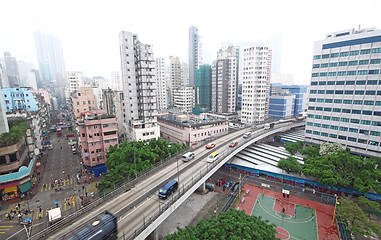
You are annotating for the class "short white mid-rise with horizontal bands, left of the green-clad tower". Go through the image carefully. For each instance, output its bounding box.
[173,85,194,113]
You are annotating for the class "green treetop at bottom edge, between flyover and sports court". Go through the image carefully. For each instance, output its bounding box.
[165,208,277,240]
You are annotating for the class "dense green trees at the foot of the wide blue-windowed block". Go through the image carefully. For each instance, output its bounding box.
[303,150,381,193]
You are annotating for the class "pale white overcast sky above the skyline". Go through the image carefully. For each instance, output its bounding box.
[0,0,381,84]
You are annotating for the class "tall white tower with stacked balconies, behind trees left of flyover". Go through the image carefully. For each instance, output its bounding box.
[119,31,160,141]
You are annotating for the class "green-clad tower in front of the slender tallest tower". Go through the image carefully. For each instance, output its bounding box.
[192,64,212,114]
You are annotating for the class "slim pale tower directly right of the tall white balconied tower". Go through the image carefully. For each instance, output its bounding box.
[155,58,167,110]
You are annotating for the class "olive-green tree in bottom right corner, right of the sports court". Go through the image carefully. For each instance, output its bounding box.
[337,198,381,236]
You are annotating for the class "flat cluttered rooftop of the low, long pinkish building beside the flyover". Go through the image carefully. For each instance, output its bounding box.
[157,114,227,127]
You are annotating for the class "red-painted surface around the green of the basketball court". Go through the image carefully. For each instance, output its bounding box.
[238,184,339,240]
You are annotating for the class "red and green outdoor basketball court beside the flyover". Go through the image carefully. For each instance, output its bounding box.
[239,184,339,240]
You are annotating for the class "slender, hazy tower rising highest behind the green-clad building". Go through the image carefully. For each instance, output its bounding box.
[188,26,202,86]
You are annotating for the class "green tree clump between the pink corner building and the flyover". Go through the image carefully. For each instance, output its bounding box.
[98,139,186,190]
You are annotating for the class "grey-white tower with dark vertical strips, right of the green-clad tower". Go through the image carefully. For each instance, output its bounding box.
[212,45,239,113]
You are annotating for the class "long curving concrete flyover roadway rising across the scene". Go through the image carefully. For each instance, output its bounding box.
[32,122,305,239]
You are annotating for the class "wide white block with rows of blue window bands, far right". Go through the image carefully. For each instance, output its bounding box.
[305,28,381,157]
